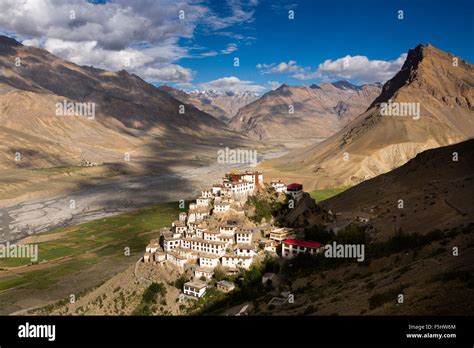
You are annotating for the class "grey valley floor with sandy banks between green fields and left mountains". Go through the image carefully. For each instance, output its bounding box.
[0,149,287,243]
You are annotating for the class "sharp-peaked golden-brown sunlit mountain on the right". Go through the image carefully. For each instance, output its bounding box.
[264,45,474,188]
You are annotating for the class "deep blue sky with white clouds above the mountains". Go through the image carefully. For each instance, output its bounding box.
[0,0,474,93]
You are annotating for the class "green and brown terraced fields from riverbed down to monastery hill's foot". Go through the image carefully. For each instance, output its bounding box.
[0,202,180,314]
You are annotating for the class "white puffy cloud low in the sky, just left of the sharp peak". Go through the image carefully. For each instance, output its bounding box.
[293,53,407,83]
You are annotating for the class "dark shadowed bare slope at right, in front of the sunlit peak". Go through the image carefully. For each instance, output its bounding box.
[322,139,474,238]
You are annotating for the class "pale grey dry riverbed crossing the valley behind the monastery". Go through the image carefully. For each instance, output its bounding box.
[0,150,286,243]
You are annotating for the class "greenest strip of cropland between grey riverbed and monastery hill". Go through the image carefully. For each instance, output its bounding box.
[0,202,181,291]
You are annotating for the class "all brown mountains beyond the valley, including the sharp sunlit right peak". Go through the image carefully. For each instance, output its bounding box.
[0,36,474,198]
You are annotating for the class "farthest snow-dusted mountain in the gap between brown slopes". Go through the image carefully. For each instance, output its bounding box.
[159,85,258,122]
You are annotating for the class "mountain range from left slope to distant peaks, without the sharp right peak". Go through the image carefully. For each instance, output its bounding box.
[0,36,386,172]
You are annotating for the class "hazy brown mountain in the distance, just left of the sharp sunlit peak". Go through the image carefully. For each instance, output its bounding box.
[230,81,380,140]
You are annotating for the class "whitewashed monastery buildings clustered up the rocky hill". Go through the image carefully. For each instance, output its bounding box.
[143,171,314,298]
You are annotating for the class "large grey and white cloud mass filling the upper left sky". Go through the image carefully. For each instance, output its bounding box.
[0,0,256,82]
